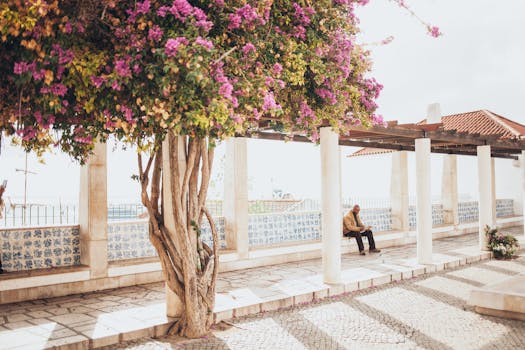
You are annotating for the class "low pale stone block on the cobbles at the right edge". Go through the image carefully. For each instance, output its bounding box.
[468,273,525,320]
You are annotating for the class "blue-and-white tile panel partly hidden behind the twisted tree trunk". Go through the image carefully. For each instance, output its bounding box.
[108,217,226,261]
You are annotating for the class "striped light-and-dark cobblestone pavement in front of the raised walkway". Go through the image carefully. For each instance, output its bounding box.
[107,232,525,350]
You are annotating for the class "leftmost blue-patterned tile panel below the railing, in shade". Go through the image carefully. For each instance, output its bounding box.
[0,226,80,272]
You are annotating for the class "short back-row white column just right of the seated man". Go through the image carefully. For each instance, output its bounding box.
[390,151,410,231]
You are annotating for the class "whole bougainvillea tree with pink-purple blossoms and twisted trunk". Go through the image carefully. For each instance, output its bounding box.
[0,0,436,337]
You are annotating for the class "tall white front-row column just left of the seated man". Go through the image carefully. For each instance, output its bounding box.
[321,127,343,283]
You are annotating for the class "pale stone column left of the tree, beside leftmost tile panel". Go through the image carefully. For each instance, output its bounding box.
[78,143,108,278]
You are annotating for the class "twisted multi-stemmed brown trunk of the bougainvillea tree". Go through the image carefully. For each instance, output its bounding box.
[138,132,219,338]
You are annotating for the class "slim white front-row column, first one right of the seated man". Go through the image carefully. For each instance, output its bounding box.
[415,138,432,264]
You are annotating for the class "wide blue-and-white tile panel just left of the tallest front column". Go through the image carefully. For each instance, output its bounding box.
[248,211,321,246]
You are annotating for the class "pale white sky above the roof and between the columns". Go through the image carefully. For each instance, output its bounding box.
[0,0,525,203]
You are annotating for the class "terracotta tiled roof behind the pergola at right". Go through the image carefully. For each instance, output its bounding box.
[349,109,525,157]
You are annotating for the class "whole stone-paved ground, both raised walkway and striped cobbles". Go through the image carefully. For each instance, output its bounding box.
[0,227,525,349]
